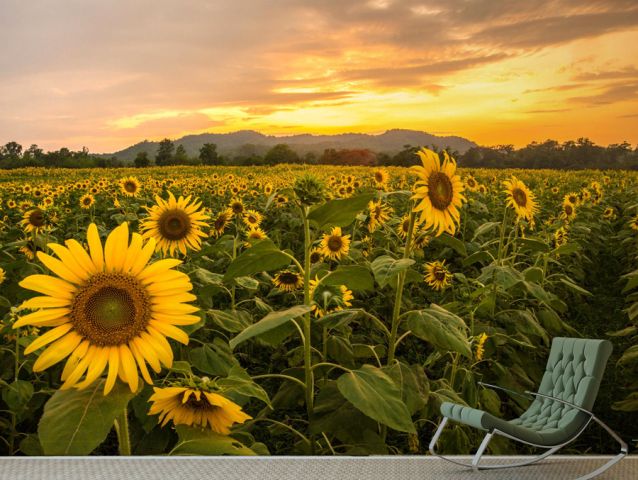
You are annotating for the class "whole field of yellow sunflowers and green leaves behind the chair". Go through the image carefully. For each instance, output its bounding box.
[0,149,638,455]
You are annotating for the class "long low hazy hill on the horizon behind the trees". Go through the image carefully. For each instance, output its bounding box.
[109,129,477,161]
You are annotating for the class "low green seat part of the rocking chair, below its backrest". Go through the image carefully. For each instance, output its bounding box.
[441,402,589,447]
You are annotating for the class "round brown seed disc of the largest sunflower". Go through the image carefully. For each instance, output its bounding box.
[70,273,151,346]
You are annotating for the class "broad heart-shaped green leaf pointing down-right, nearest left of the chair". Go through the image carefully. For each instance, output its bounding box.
[337,365,416,433]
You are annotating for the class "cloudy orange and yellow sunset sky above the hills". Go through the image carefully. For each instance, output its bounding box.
[0,0,638,152]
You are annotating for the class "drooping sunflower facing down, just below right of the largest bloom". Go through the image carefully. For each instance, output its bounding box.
[148,386,252,435]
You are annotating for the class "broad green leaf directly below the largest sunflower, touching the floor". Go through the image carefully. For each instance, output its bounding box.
[38,380,135,455]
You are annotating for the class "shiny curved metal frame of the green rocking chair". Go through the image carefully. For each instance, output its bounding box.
[429,382,628,480]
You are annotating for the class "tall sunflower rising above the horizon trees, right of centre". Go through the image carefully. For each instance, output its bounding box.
[412,148,465,236]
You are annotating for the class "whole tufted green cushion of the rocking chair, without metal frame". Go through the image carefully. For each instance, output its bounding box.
[441,337,612,446]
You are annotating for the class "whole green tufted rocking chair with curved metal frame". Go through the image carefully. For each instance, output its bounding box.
[430,337,627,480]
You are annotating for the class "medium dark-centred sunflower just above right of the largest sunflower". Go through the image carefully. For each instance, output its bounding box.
[140,192,208,256]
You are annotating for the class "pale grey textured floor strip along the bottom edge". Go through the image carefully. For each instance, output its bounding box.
[0,455,638,480]
